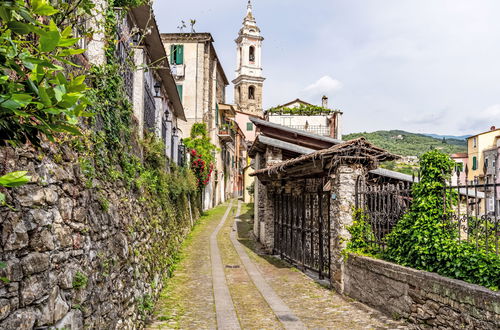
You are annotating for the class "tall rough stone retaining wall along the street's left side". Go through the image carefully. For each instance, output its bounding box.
[0,148,196,329]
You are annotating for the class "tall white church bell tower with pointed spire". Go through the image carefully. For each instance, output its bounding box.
[233,0,265,116]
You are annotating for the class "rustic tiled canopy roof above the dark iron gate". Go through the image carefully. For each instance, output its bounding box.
[250,137,400,176]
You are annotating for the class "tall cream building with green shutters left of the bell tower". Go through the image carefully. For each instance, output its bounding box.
[161,33,230,209]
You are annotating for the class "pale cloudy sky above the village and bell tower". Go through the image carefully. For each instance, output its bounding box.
[154,0,500,135]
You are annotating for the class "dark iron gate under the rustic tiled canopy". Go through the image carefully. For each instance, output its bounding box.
[274,179,330,279]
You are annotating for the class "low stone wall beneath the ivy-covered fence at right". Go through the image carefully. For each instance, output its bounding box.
[344,255,500,329]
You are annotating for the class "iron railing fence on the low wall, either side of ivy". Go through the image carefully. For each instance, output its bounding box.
[355,176,500,255]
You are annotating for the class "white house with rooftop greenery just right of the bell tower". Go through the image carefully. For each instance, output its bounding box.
[265,96,342,140]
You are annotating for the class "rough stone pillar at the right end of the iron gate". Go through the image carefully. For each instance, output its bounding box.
[330,164,367,293]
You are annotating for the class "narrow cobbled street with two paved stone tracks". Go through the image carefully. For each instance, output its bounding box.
[149,201,405,329]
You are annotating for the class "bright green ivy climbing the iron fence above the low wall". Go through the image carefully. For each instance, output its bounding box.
[384,150,500,290]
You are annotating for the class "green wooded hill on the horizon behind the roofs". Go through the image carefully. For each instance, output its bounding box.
[342,130,467,156]
